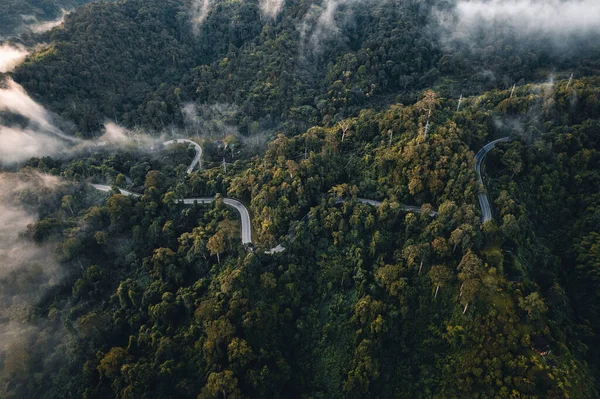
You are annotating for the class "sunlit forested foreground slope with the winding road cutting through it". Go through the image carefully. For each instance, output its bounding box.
[4,79,600,398]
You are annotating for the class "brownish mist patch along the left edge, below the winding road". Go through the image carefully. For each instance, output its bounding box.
[0,171,66,396]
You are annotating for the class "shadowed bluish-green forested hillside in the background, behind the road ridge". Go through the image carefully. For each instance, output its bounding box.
[15,0,599,137]
